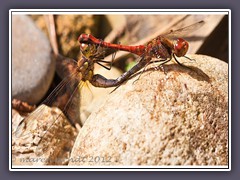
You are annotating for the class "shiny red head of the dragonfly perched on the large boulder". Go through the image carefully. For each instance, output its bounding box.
[174,38,189,57]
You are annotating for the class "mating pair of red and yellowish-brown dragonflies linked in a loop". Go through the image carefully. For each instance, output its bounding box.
[16,21,204,139]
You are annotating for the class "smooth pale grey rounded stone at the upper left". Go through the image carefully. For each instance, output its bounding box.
[12,15,55,104]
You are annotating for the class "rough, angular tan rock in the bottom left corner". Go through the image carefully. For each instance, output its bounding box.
[12,105,76,166]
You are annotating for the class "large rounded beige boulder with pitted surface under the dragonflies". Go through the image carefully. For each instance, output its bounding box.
[69,55,228,166]
